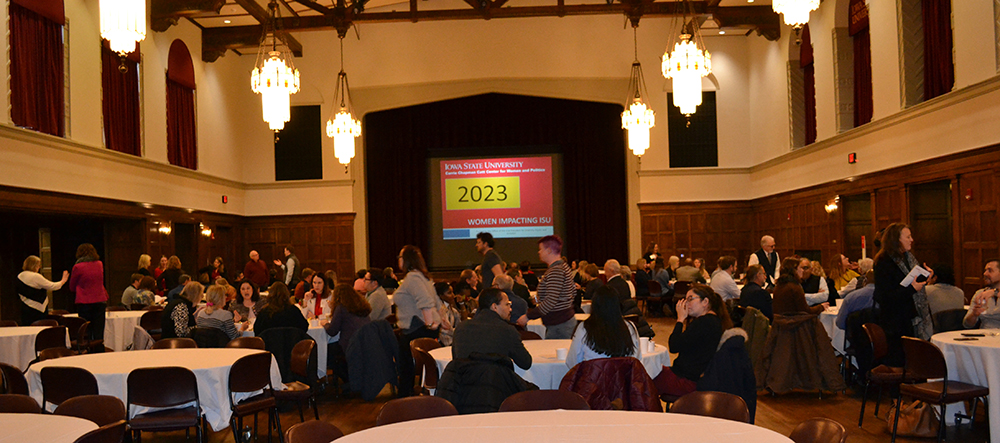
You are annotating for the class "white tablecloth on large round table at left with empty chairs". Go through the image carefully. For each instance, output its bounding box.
[25,348,282,431]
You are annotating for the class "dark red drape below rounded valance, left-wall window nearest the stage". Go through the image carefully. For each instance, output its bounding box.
[167,79,198,169]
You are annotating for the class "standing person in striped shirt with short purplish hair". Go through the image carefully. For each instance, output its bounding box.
[528,235,576,339]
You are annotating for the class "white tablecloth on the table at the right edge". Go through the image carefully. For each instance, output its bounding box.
[931,329,1000,441]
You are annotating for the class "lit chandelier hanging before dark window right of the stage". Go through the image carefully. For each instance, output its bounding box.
[661,3,712,121]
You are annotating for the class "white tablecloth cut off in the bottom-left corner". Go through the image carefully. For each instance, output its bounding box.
[0,414,97,443]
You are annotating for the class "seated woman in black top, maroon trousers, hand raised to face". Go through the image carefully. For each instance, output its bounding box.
[653,284,733,396]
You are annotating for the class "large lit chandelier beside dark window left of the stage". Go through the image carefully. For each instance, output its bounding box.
[250,0,299,131]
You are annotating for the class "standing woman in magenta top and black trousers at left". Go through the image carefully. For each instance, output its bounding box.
[69,243,108,339]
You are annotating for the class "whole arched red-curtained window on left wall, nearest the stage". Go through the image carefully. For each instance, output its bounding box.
[167,40,198,169]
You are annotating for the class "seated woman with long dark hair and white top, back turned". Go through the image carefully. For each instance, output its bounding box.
[566,285,642,368]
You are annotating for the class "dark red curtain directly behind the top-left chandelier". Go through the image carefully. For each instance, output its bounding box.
[101,46,142,156]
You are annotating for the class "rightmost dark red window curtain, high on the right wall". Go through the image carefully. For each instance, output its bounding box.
[921,0,955,100]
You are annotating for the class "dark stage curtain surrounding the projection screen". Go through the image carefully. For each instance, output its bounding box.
[364,94,629,266]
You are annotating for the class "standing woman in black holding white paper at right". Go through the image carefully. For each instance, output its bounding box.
[872,223,927,367]
